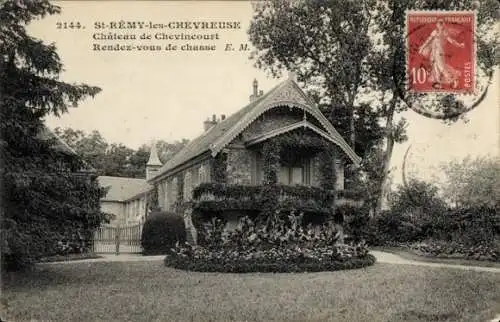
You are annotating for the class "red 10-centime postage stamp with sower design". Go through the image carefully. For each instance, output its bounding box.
[406,11,476,94]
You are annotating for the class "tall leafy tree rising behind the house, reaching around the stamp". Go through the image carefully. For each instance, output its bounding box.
[249,0,498,213]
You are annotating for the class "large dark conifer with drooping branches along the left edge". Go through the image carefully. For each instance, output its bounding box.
[0,0,106,268]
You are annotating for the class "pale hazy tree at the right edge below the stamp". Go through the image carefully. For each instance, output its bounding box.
[441,157,500,207]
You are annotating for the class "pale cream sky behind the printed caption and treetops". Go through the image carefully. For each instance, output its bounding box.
[28,1,500,184]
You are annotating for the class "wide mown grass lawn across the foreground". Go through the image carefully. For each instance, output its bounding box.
[2,261,500,322]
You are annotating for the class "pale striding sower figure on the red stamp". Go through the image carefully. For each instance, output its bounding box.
[418,19,464,88]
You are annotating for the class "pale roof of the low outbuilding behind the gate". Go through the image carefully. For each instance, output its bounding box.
[97,176,151,202]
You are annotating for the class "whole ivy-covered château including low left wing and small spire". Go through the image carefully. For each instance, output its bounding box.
[94,75,361,239]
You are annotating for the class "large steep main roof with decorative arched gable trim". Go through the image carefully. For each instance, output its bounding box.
[151,78,361,181]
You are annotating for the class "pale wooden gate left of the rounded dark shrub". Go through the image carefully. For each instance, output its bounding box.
[93,223,143,255]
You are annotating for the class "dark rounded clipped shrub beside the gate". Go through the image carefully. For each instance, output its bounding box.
[141,212,186,255]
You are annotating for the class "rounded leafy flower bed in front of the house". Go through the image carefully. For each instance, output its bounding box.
[165,215,375,273]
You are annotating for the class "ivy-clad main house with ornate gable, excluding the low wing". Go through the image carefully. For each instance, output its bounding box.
[147,75,361,242]
